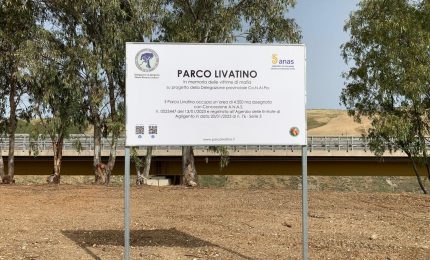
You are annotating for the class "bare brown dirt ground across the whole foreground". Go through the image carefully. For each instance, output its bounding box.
[0,184,430,259]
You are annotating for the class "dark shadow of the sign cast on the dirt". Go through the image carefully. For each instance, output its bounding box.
[61,228,250,259]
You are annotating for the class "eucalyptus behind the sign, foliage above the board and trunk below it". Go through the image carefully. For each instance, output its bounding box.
[158,0,301,186]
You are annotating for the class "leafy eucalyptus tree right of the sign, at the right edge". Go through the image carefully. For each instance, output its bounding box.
[341,0,430,193]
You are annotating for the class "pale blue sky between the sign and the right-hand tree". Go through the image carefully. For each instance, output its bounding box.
[287,0,359,109]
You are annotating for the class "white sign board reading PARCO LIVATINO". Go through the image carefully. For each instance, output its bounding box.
[126,43,306,146]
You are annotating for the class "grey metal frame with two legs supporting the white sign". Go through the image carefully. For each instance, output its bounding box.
[124,45,308,260]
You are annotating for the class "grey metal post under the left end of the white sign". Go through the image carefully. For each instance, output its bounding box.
[124,147,130,260]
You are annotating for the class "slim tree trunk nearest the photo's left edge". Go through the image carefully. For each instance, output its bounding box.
[2,84,17,184]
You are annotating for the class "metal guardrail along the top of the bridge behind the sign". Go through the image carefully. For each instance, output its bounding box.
[0,134,378,152]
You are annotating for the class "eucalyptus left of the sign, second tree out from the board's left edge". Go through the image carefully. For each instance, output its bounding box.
[38,0,106,182]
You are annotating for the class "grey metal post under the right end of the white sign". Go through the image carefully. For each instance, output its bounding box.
[302,145,308,260]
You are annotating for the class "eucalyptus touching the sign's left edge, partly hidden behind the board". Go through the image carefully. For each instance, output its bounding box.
[88,0,164,184]
